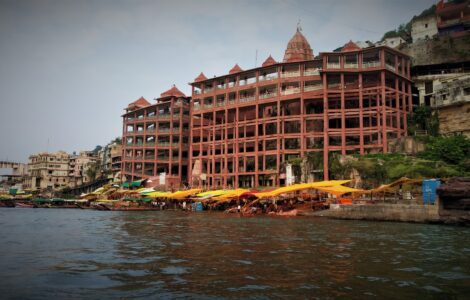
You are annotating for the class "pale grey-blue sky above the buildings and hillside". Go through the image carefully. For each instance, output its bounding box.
[0,0,436,162]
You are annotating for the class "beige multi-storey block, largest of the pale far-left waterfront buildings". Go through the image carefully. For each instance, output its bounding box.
[24,151,70,190]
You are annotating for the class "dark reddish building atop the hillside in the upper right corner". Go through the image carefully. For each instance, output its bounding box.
[436,0,470,36]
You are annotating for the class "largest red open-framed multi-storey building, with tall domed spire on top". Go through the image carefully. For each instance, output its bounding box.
[187,29,411,187]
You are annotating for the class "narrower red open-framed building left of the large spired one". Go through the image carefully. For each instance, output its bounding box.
[121,86,190,187]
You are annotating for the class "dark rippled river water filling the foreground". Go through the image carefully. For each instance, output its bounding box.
[0,208,470,299]
